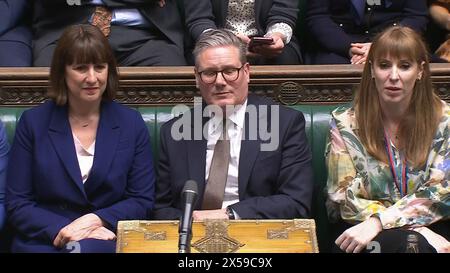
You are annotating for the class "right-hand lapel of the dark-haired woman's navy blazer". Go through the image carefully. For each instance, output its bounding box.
[84,102,120,194]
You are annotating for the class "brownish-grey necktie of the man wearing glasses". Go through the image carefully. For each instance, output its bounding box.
[202,121,230,209]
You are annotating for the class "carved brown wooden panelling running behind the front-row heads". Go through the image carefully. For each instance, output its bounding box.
[0,64,450,106]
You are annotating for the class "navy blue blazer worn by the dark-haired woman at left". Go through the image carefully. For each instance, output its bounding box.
[6,101,155,251]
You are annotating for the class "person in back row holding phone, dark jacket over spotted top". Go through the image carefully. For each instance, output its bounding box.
[184,0,302,65]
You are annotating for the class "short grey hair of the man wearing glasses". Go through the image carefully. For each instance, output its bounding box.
[192,29,247,66]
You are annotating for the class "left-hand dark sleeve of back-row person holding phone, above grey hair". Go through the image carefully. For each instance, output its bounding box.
[183,0,217,41]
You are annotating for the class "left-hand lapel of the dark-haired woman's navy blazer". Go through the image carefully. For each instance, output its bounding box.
[48,106,86,197]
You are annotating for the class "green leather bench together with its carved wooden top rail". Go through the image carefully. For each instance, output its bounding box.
[0,64,450,252]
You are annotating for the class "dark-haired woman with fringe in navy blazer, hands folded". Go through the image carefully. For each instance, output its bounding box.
[6,25,155,252]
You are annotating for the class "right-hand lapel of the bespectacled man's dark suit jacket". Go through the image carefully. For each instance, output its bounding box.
[238,95,262,198]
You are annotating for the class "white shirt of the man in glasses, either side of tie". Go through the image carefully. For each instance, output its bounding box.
[205,100,247,208]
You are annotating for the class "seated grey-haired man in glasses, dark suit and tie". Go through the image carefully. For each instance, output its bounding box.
[153,30,313,220]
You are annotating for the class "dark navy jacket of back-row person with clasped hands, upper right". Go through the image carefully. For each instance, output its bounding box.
[306,0,428,59]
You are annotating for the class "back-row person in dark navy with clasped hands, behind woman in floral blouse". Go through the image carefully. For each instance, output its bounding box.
[305,0,427,64]
